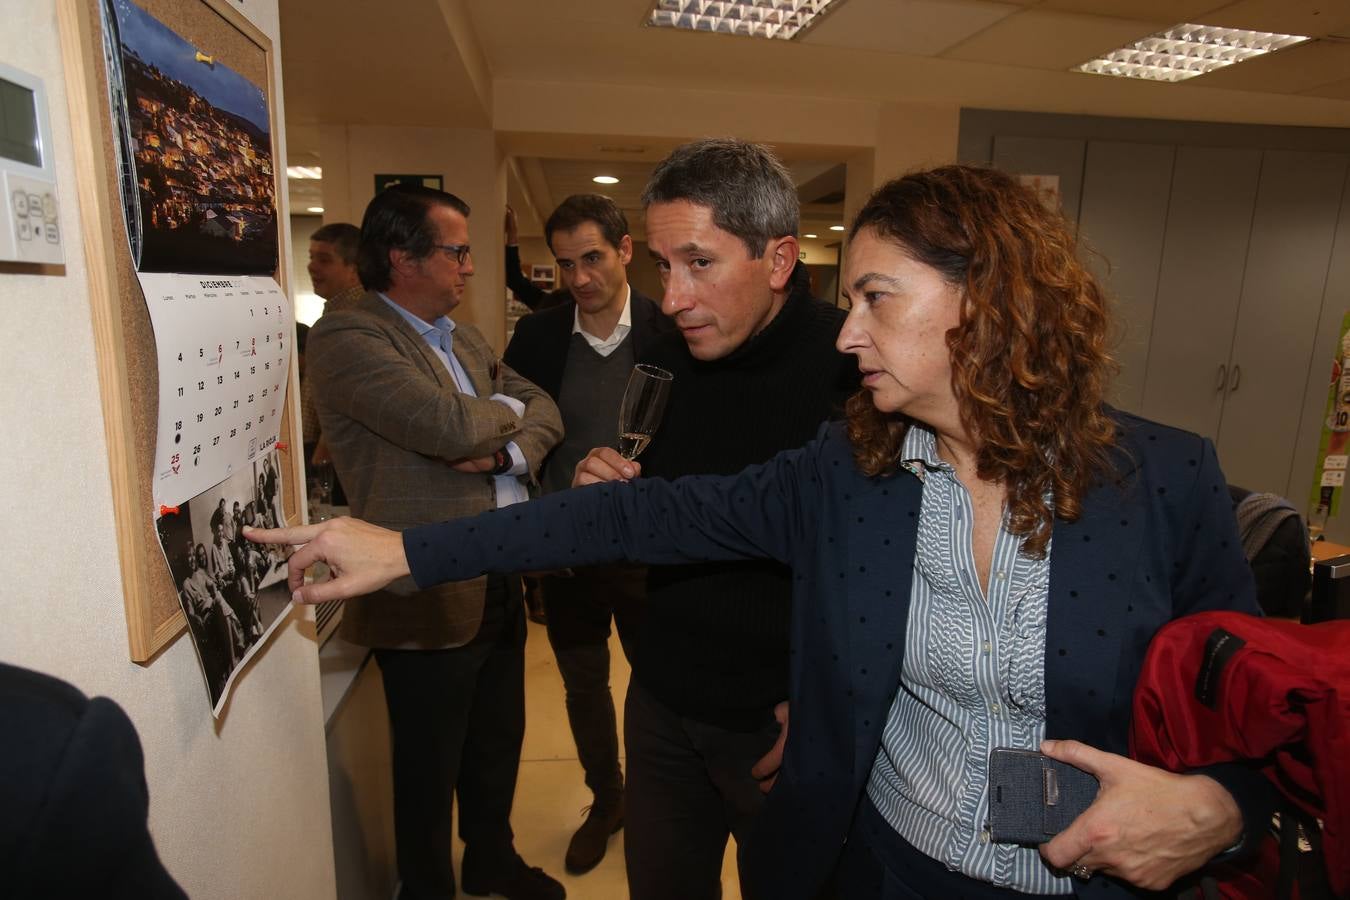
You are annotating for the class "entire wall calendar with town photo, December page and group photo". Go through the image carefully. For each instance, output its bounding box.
[103,0,296,715]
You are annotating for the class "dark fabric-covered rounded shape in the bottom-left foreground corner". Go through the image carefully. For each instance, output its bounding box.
[0,664,186,900]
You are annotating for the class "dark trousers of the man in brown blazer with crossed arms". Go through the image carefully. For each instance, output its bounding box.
[375,578,525,900]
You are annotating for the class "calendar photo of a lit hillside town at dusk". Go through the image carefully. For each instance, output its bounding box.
[112,0,278,274]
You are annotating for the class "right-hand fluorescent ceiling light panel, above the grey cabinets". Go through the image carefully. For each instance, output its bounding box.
[1073,23,1311,81]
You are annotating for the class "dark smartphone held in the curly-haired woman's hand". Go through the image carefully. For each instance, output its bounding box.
[990,748,1100,845]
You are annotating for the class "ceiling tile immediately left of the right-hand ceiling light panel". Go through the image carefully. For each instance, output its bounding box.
[941,9,1170,69]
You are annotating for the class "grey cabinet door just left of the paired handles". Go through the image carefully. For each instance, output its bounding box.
[1143,147,1258,439]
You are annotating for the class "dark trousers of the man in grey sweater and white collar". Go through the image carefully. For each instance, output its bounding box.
[541,565,647,808]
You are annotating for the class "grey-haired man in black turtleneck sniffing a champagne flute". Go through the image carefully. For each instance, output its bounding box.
[574,140,857,900]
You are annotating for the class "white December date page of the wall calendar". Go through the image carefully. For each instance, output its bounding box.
[140,273,296,510]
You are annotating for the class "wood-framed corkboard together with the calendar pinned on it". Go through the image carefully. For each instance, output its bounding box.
[64,0,304,669]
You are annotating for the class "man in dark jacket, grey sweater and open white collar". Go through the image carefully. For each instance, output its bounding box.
[504,194,674,874]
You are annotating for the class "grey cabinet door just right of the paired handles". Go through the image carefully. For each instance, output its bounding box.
[1218,150,1350,494]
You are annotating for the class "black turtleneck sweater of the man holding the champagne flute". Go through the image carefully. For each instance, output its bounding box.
[632,269,857,731]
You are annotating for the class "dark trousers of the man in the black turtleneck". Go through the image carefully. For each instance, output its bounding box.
[624,680,779,900]
